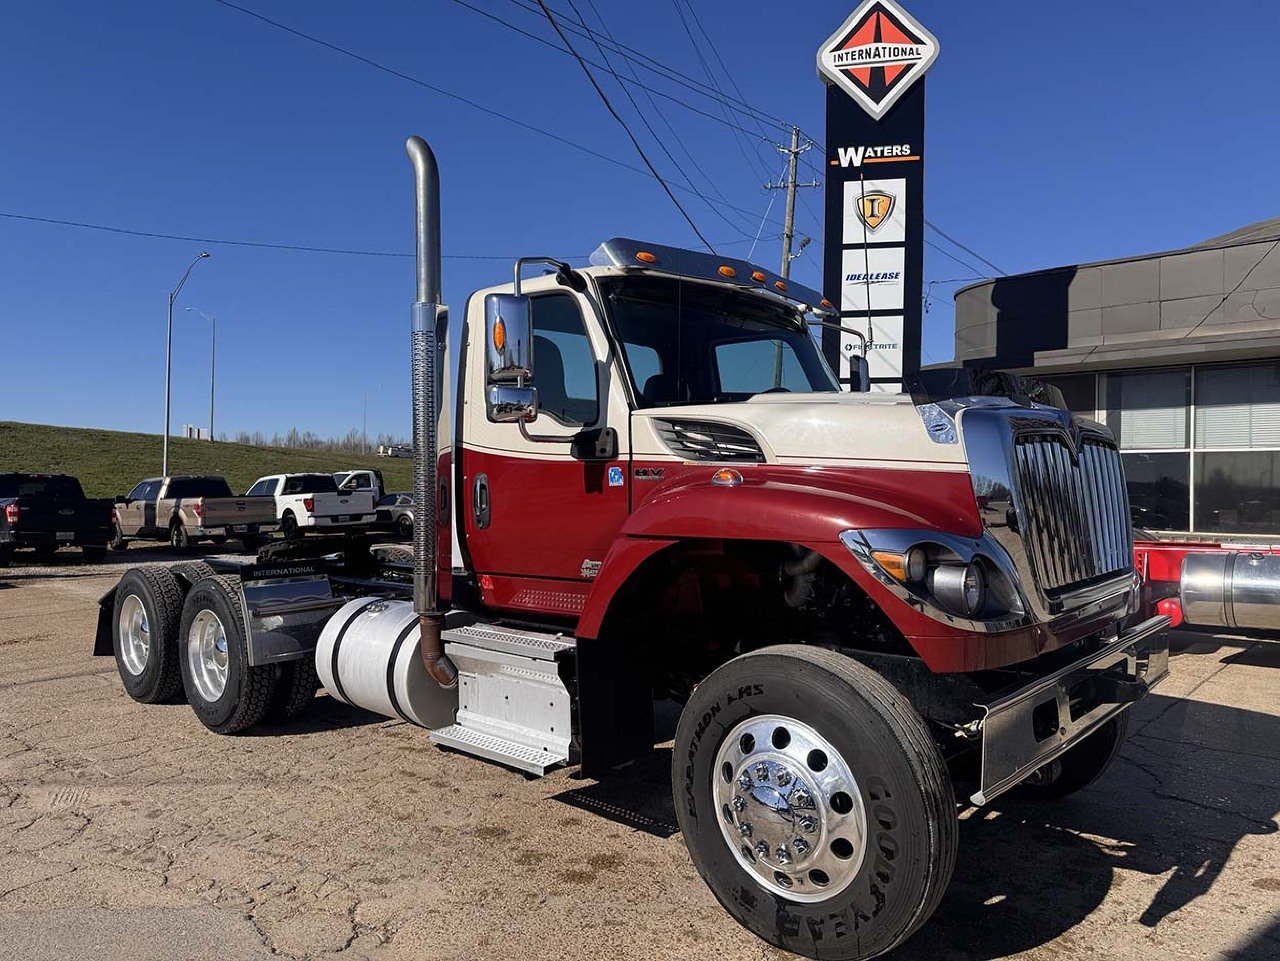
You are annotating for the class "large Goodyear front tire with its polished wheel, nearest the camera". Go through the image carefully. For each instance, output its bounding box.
[672,645,956,961]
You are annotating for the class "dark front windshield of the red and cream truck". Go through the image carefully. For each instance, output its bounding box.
[600,276,840,407]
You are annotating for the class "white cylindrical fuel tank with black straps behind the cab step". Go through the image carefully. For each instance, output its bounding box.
[316,598,458,729]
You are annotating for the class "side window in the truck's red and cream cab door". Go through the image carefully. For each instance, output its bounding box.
[532,294,599,427]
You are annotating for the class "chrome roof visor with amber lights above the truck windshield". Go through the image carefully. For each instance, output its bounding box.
[591,237,838,317]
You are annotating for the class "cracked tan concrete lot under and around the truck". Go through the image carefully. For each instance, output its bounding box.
[0,552,1280,961]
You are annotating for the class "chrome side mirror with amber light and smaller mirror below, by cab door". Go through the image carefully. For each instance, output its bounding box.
[484,293,538,424]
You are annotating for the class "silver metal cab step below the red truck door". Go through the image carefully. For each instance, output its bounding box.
[431,624,576,777]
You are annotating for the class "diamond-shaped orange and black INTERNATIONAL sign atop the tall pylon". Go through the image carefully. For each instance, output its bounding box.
[818,0,938,120]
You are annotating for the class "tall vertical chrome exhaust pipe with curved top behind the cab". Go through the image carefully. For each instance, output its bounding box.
[404,137,458,687]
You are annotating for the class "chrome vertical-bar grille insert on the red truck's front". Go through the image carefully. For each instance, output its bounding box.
[1014,435,1133,592]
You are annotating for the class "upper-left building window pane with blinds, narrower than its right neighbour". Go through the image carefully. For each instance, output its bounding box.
[1107,370,1192,450]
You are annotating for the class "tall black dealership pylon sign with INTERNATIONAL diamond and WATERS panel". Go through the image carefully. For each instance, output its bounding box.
[818,0,938,390]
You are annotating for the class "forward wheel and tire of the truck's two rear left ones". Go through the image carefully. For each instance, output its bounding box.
[178,575,279,735]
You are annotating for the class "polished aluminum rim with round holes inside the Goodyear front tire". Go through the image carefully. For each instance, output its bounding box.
[712,714,867,902]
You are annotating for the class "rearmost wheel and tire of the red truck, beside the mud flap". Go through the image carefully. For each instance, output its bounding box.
[111,566,182,704]
